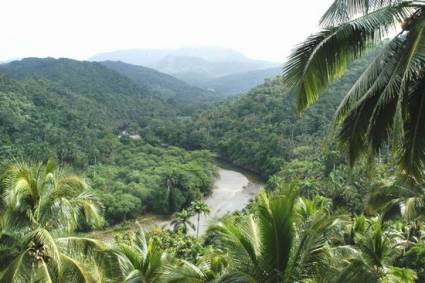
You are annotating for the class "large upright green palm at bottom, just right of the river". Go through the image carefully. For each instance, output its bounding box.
[209,188,333,282]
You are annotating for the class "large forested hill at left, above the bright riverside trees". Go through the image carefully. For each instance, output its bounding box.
[0,58,214,166]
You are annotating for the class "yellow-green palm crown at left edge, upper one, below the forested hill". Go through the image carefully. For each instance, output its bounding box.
[0,161,102,232]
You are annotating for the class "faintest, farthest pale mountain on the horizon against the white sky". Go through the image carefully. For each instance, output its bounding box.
[90,47,277,86]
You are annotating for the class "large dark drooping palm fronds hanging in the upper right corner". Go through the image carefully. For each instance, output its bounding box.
[283,0,425,178]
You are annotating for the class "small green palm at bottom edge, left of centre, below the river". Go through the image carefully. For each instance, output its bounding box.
[115,228,166,283]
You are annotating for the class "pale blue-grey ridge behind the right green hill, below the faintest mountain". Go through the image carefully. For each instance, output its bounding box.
[199,67,282,95]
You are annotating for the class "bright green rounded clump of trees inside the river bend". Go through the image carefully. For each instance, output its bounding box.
[87,141,216,223]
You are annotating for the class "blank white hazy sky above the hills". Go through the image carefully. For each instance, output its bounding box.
[0,0,332,61]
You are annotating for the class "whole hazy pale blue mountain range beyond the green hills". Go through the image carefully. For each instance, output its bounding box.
[90,47,280,95]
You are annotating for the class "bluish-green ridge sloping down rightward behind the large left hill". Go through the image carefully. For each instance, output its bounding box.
[99,61,221,111]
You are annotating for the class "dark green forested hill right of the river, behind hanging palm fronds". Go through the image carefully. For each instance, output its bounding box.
[168,54,368,176]
